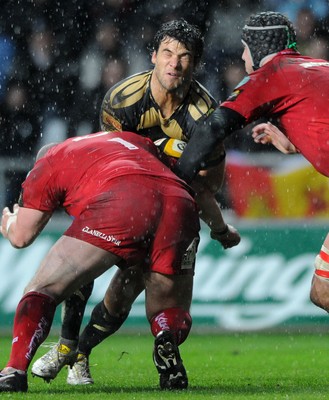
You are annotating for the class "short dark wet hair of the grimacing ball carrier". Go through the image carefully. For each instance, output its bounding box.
[150,18,204,65]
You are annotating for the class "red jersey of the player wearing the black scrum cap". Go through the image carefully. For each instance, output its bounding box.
[221,50,329,176]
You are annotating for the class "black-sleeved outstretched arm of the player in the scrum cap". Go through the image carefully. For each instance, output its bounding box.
[174,107,245,183]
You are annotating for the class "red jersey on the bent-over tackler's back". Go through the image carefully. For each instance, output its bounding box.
[21,132,190,217]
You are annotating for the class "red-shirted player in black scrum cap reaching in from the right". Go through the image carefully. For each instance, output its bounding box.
[175,11,329,328]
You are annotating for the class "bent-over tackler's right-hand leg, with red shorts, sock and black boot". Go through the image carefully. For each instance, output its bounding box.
[145,197,200,389]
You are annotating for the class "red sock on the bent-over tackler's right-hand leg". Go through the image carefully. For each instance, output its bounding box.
[150,307,192,345]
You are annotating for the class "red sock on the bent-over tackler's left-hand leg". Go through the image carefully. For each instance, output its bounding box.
[7,292,56,371]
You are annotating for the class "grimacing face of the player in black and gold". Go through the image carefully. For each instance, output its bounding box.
[152,38,194,92]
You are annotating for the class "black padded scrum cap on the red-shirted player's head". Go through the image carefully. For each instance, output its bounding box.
[242,11,297,69]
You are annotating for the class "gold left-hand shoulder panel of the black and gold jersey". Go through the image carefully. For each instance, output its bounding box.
[104,70,152,108]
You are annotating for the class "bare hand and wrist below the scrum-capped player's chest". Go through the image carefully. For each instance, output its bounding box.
[252,122,298,154]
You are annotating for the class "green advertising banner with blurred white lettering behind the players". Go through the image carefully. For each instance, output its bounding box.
[0,221,329,331]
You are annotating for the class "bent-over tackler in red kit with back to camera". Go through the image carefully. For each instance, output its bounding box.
[0,132,200,392]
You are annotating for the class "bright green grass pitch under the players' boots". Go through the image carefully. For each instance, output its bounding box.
[0,332,329,400]
